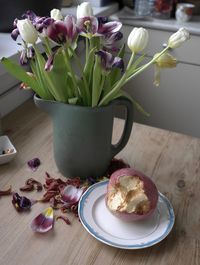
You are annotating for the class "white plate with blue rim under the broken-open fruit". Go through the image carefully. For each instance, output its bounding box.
[78,178,175,249]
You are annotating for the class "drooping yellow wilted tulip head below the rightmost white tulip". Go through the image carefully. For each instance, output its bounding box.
[154,53,177,68]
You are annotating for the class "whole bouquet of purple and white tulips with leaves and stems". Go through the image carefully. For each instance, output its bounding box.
[1,2,189,111]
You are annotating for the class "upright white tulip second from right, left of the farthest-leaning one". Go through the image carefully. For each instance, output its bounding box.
[127,28,149,53]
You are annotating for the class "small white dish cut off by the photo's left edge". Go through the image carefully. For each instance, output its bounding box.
[0,135,17,165]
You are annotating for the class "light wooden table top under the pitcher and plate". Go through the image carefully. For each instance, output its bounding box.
[0,101,200,265]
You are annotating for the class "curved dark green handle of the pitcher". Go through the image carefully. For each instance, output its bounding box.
[111,98,133,157]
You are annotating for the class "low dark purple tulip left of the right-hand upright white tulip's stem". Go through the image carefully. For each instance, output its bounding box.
[95,50,124,72]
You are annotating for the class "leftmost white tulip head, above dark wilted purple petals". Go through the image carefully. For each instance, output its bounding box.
[17,18,38,44]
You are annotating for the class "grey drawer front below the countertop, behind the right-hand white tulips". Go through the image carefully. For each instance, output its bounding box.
[122,26,200,65]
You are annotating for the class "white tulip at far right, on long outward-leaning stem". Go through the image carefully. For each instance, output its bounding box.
[168,28,190,49]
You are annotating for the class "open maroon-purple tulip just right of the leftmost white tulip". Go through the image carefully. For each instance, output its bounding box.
[45,15,78,44]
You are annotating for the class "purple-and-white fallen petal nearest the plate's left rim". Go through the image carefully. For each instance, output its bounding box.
[61,185,84,204]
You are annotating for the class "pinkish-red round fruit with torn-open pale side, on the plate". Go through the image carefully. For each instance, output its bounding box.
[106,168,158,221]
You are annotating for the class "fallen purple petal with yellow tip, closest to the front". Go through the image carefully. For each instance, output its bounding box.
[31,207,54,233]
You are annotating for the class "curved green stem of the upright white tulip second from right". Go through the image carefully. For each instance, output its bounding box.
[99,53,135,106]
